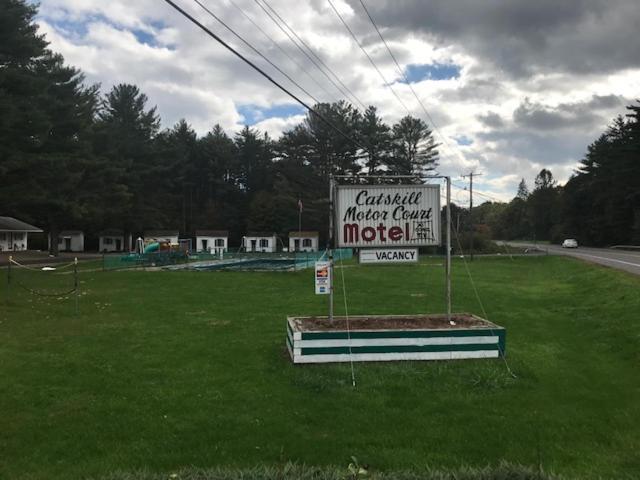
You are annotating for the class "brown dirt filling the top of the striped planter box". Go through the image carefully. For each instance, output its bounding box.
[294,313,496,332]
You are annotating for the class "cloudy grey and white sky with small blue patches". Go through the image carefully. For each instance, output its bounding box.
[37,0,640,203]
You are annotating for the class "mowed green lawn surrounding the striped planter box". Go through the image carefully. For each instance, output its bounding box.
[0,257,640,479]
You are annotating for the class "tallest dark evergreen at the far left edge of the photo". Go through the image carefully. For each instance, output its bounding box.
[0,0,97,254]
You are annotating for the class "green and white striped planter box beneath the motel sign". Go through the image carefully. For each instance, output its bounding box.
[287,314,506,363]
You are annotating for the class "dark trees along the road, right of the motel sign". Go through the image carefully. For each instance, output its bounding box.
[465,102,640,246]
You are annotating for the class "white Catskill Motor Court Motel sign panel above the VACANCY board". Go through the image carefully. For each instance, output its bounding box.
[335,184,441,247]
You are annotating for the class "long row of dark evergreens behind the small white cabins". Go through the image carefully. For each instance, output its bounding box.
[0,0,438,253]
